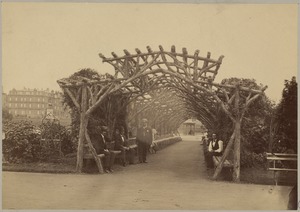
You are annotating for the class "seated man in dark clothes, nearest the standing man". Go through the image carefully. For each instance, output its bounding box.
[114,127,134,166]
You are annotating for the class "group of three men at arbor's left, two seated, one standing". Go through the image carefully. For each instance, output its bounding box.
[91,119,153,173]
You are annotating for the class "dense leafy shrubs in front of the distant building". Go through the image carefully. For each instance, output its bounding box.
[3,121,76,163]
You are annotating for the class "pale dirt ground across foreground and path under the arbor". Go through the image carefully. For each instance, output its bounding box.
[2,136,291,210]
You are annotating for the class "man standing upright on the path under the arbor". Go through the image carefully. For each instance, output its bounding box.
[136,119,153,163]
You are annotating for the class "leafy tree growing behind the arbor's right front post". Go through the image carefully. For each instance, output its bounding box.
[217,78,274,167]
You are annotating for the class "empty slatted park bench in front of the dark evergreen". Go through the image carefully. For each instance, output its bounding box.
[266,152,297,185]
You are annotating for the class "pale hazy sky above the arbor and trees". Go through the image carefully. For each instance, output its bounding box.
[2,2,298,101]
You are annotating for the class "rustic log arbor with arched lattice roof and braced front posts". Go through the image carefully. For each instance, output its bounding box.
[58,46,266,181]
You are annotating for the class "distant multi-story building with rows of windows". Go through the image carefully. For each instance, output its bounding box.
[6,89,70,126]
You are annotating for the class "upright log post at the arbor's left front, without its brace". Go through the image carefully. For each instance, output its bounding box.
[76,86,88,173]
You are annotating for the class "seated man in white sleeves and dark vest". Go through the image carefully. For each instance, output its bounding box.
[207,133,223,168]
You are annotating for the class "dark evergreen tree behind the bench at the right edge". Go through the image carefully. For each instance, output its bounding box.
[273,77,297,152]
